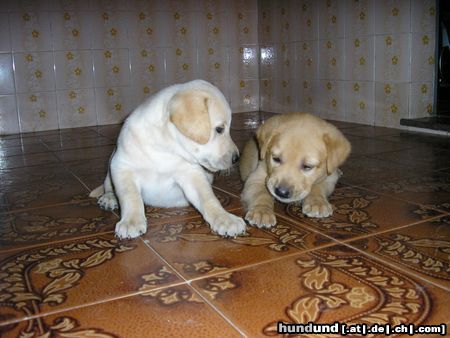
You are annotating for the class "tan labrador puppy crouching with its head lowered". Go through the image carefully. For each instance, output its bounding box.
[239,113,351,228]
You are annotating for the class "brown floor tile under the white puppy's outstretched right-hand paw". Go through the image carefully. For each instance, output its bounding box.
[143,214,332,279]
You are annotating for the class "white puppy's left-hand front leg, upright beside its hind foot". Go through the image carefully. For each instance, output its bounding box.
[111,169,147,238]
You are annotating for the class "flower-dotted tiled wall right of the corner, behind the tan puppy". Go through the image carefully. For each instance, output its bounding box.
[259,0,436,127]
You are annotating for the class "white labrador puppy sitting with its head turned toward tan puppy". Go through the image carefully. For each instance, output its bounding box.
[90,80,245,238]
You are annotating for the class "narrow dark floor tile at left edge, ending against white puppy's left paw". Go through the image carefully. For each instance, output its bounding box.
[0,200,118,252]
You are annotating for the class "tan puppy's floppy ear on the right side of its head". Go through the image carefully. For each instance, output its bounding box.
[323,125,351,175]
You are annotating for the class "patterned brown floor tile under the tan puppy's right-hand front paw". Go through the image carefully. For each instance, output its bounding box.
[276,187,442,240]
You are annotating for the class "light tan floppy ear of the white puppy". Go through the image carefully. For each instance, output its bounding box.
[168,90,211,144]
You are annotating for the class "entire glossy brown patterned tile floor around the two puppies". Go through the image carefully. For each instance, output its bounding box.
[0,113,450,337]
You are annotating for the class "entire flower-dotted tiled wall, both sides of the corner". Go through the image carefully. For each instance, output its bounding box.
[0,0,436,134]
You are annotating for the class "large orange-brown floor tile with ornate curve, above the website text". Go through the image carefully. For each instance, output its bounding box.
[193,246,450,337]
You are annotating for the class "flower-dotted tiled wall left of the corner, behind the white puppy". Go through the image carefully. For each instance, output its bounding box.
[0,0,259,134]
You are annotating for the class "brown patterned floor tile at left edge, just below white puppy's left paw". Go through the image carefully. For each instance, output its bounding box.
[0,235,182,330]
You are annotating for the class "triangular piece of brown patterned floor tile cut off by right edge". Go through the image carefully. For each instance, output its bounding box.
[349,216,450,290]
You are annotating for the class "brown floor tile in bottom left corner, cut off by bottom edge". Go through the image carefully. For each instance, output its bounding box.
[0,286,242,338]
